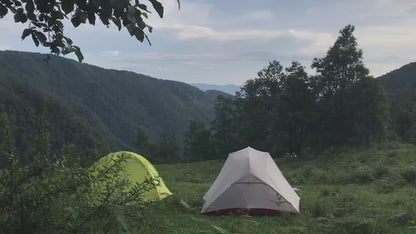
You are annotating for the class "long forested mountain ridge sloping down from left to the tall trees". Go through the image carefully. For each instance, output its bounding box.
[0,51,224,152]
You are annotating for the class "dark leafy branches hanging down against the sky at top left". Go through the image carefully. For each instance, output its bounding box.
[0,0,167,62]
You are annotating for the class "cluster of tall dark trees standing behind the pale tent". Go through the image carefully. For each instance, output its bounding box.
[177,25,394,161]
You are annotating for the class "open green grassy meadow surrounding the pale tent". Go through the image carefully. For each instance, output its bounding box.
[142,143,416,233]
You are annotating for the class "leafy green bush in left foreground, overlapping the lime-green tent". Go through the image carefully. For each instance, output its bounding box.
[0,112,154,233]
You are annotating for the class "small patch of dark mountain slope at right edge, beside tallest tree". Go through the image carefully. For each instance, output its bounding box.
[379,62,416,98]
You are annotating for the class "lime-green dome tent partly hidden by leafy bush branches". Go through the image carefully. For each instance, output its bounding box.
[90,151,172,201]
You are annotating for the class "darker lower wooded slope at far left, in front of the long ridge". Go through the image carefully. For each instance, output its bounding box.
[0,78,110,161]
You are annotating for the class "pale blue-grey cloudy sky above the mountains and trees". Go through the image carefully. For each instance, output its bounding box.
[0,0,416,85]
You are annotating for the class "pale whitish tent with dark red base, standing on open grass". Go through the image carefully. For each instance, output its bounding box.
[201,147,300,215]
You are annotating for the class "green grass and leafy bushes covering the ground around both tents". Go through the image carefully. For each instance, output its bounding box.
[4,103,416,233]
